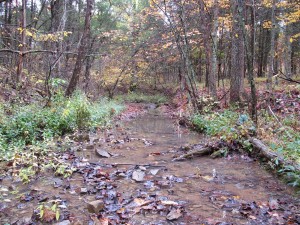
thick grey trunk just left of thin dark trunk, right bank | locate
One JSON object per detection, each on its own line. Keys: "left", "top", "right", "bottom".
{"left": 230, "top": 0, "right": 245, "bottom": 104}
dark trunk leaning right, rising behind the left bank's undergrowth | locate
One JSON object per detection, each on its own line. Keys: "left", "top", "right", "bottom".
{"left": 65, "top": 0, "right": 93, "bottom": 96}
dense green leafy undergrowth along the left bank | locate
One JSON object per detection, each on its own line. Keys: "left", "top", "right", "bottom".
{"left": 0, "top": 93, "right": 123, "bottom": 159}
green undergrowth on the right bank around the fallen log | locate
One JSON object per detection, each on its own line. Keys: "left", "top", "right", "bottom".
{"left": 191, "top": 110, "right": 300, "bottom": 187}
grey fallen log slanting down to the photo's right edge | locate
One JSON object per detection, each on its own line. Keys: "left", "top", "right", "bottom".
{"left": 249, "top": 138, "right": 300, "bottom": 171}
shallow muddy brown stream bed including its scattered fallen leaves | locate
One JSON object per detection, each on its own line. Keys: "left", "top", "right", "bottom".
{"left": 0, "top": 110, "right": 300, "bottom": 224}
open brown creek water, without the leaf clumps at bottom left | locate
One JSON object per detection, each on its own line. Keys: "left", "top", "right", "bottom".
{"left": 0, "top": 111, "right": 299, "bottom": 224}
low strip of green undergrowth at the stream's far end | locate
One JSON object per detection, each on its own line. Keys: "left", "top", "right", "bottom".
{"left": 116, "top": 92, "right": 168, "bottom": 104}
